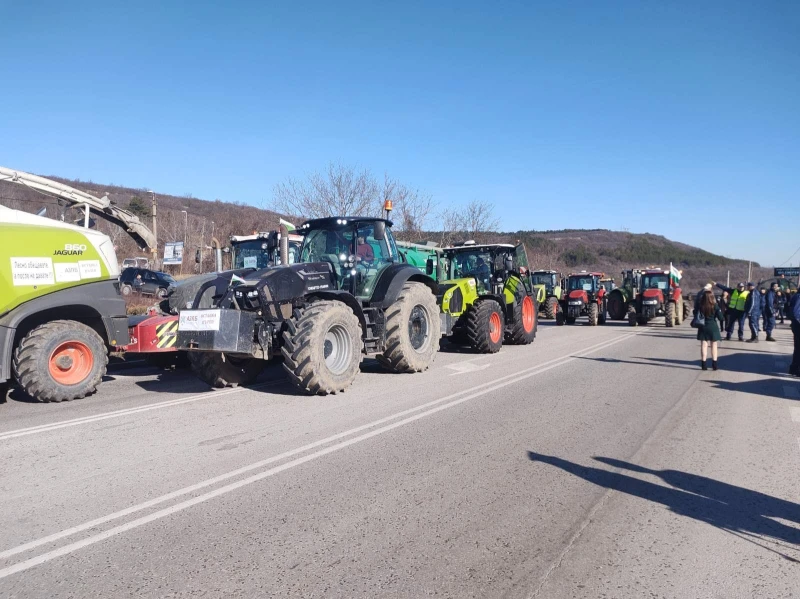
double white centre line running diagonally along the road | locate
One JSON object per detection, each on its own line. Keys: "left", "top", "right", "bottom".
{"left": 0, "top": 333, "right": 638, "bottom": 578}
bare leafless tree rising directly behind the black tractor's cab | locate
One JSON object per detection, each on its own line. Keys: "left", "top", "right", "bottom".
{"left": 273, "top": 162, "right": 381, "bottom": 218}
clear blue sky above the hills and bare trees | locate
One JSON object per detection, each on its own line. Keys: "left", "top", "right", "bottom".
{"left": 0, "top": 0, "right": 800, "bottom": 264}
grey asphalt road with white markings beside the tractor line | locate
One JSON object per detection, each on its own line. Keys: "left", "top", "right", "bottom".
{"left": 0, "top": 322, "right": 800, "bottom": 599}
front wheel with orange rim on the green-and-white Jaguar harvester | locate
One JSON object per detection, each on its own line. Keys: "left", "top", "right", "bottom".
{"left": 13, "top": 320, "right": 108, "bottom": 401}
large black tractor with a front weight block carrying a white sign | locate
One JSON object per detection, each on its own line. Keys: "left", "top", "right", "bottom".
{"left": 177, "top": 217, "right": 441, "bottom": 395}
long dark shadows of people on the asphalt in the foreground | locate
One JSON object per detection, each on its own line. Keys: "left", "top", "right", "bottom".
{"left": 528, "top": 451, "right": 800, "bottom": 563}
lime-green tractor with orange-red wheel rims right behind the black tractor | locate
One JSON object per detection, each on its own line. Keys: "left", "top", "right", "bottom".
{"left": 439, "top": 242, "right": 538, "bottom": 353}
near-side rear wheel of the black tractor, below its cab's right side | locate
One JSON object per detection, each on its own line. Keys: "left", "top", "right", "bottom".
{"left": 377, "top": 281, "right": 442, "bottom": 372}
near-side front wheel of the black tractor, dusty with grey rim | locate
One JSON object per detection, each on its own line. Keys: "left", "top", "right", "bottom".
{"left": 281, "top": 300, "right": 363, "bottom": 395}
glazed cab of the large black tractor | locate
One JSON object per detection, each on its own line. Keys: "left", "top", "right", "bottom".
{"left": 299, "top": 217, "right": 401, "bottom": 301}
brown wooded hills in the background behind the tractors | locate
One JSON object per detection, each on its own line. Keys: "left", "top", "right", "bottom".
{"left": 0, "top": 176, "right": 772, "bottom": 291}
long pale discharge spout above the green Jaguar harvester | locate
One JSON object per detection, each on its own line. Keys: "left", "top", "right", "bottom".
{"left": 0, "top": 166, "right": 156, "bottom": 251}
